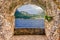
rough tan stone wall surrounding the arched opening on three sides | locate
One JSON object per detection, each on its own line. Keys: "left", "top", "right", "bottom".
{"left": 0, "top": 0, "right": 60, "bottom": 40}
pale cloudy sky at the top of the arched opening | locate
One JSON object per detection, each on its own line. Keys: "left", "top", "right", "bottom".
{"left": 17, "top": 4, "right": 43, "bottom": 14}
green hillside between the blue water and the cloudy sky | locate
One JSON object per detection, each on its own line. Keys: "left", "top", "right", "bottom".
{"left": 14, "top": 10, "right": 45, "bottom": 19}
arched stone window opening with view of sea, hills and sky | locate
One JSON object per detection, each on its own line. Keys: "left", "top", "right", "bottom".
{"left": 14, "top": 4, "right": 45, "bottom": 35}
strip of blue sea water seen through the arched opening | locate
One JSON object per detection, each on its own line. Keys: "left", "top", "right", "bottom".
{"left": 15, "top": 19, "right": 44, "bottom": 28}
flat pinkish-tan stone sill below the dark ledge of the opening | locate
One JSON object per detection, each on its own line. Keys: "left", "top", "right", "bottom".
{"left": 12, "top": 35, "right": 48, "bottom": 40}
